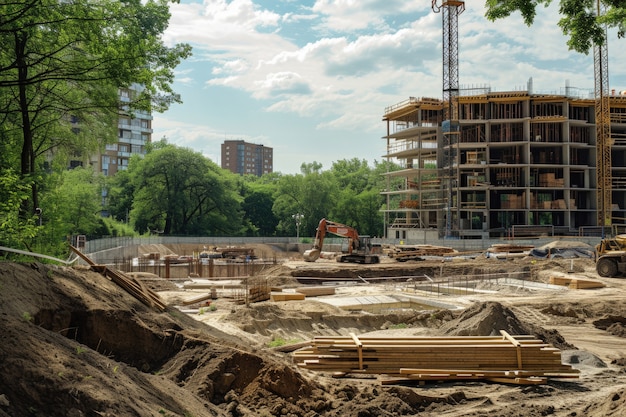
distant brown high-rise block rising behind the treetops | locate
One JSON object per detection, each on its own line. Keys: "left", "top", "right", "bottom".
{"left": 222, "top": 140, "right": 274, "bottom": 177}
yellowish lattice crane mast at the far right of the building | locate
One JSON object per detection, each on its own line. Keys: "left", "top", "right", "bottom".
{"left": 593, "top": 0, "right": 612, "bottom": 231}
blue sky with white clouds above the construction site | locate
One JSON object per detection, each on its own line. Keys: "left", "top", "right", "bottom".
{"left": 152, "top": 0, "right": 626, "bottom": 174}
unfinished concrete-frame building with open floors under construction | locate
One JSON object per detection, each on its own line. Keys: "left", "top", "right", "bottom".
{"left": 383, "top": 91, "right": 626, "bottom": 240}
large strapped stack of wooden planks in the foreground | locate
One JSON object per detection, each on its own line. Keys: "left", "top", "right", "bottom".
{"left": 294, "top": 331, "right": 578, "bottom": 384}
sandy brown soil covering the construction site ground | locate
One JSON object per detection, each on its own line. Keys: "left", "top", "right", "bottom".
{"left": 0, "top": 242, "right": 626, "bottom": 417}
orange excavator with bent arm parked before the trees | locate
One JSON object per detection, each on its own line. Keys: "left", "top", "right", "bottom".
{"left": 303, "top": 219, "right": 380, "bottom": 264}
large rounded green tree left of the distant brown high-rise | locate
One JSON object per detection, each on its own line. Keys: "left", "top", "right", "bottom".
{"left": 128, "top": 142, "right": 242, "bottom": 236}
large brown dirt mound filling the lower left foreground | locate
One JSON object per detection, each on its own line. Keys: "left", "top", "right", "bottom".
{"left": 0, "top": 263, "right": 332, "bottom": 416}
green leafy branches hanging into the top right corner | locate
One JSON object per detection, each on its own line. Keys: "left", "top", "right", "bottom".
{"left": 486, "top": 0, "right": 626, "bottom": 54}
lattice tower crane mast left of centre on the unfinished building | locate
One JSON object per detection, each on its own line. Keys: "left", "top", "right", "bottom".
{"left": 432, "top": 0, "right": 465, "bottom": 237}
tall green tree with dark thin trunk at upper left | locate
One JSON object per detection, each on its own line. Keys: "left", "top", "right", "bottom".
{"left": 0, "top": 0, "right": 190, "bottom": 216}
